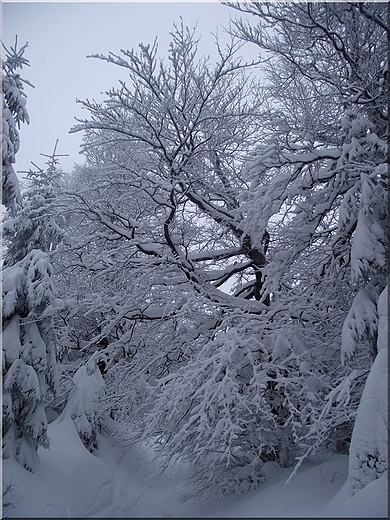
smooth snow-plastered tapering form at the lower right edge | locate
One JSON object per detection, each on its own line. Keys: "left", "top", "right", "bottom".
{"left": 349, "top": 286, "right": 389, "bottom": 494}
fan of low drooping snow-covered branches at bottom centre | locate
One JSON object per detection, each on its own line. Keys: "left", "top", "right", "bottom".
{"left": 134, "top": 315, "right": 320, "bottom": 494}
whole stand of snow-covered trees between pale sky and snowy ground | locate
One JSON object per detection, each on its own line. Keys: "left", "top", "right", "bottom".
{"left": 2, "top": 2, "right": 389, "bottom": 516}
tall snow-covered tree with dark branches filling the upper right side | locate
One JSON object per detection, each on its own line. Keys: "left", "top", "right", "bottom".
{"left": 228, "top": 2, "right": 389, "bottom": 492}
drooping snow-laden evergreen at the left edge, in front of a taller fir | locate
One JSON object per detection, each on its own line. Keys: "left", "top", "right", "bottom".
{"left": 2, "top": 249, "right": 58, "bottom": 471}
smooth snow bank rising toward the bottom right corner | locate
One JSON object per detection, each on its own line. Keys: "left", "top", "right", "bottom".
{"left": 213, "top": 456, "right": 388, "bottom": 518}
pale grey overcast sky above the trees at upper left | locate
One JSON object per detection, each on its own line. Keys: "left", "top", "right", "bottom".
{"left": 2, "top": 0, "right": 256, "bottom": 176}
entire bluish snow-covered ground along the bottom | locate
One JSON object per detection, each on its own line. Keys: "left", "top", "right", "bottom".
{"left": 3, "top": 417, "right": 388, "bottom": 518}
